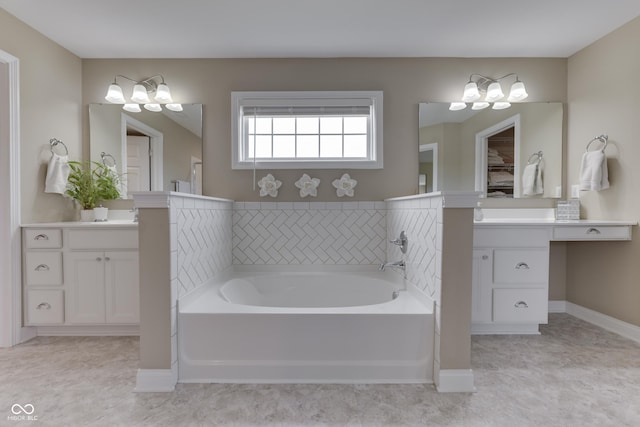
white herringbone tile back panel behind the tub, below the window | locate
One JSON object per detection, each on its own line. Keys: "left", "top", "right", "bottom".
{"left": 233, "top": 202, "right": 386, "bottom": 265}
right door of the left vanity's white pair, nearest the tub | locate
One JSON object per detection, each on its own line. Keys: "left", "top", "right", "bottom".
{"left": 104, "top": 251, "right": 140, "bottom": 323}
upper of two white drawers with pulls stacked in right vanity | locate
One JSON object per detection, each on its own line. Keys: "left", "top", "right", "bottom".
{"left": 493, "top": 249, "right": 549, "bottom": 284}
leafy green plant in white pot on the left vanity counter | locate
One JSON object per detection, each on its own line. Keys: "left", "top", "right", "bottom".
{"left": 65, "top": 161, "right": 120, "bottom": 221}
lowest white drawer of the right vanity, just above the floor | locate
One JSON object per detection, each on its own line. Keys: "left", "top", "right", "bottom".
{"left": 493, "top": 289, "right": 549, "bottom": 323}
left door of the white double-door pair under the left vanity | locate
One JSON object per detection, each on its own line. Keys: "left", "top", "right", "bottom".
{"left": 64, "top": 252, "right": 105, "bottom": 324}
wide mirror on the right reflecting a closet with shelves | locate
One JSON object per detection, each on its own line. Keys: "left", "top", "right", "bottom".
{"left": 418, "top": 102, "right": 564, "bottom": 198}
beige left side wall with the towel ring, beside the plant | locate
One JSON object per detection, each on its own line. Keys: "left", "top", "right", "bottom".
{"left": 0, "top": 9, "right": 84, "bottom": 223}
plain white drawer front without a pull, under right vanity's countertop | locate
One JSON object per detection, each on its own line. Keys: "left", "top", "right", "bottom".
{"left": 473, "top": 225, "right": 551, "bottom": 248}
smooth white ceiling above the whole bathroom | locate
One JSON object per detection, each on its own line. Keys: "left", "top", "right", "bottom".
{"left": 0, "top": 0, "right": 640, "bottom": 58}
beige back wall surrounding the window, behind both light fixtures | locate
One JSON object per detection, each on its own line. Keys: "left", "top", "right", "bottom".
{"left": 82, "top": 58, "right": 566, "bottom": 201}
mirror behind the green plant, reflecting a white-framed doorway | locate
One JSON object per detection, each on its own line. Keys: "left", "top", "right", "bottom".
{"left": 89, "top": 104, "right": 202, "bottom": 198}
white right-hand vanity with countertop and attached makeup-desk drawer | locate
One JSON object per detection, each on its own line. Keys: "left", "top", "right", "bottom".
{"left": 471, "top": 217, "right": 634, "bottom": 334}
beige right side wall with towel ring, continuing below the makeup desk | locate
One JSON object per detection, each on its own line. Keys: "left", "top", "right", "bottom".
{"left": 566, "top": 18, "right": 640, "bottom": 326}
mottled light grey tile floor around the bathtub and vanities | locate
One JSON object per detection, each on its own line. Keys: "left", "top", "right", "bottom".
{"left": 0, "top": 314, "right": 640, "bottom": 427}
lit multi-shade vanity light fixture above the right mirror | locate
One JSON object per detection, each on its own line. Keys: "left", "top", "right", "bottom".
{"left": 449, "top": 73, "right": 529, "bottom": 111}
